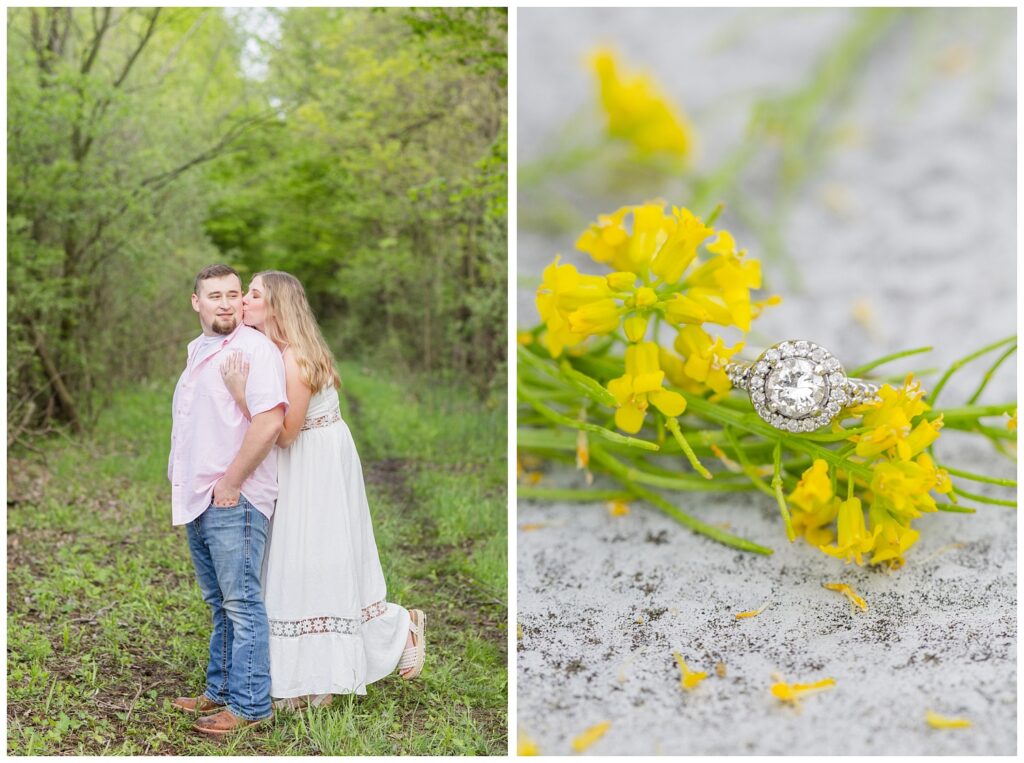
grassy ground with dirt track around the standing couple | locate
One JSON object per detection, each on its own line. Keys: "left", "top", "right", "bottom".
{"left": 7, "top": 365, "right": 508, "bottom": 755}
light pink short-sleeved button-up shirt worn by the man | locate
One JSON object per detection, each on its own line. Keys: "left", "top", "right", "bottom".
{"left": 167, "top": 325, "right": 288, "bottom": 524}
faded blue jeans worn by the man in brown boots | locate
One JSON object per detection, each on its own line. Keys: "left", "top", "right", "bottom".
{"left": 187, "top": 496, "right": 271, "bottom": 721}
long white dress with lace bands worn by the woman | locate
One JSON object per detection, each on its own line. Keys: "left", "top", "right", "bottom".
{"left": 263, "top": 386, "right": 410, "bottom": 698}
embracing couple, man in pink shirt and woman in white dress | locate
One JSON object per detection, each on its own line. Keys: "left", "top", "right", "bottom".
{"left": 168, "top": 265, "right": 425, "bottom": 734}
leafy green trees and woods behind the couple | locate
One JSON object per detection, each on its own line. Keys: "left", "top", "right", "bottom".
{"left": 7, "top": 8, "right": 508, "bottom": 444}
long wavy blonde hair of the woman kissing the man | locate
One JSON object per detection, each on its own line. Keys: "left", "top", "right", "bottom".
{"left": 253, "top": 270, "right": 341, "bottom": 392}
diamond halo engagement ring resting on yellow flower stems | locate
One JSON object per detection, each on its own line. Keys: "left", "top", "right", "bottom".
{"left": 725, "top": 340, "right": 879, "bottom": 432}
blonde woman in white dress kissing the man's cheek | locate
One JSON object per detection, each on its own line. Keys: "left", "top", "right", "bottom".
{"left": 221, "top": 270, "right": 426, "bottom": 708}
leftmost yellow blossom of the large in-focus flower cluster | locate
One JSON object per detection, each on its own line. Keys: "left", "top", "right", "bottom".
{"left": 537, "top": 252, "right": 617, "bottom": 357}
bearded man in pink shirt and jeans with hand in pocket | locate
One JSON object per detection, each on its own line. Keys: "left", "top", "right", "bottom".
{"left": 167, "top": 265, "right": 288, "bottom": 735}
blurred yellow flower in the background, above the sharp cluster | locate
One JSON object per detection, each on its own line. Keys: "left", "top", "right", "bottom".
{"left": 592, "top": 50, "right": 693, "bottom": 157}
